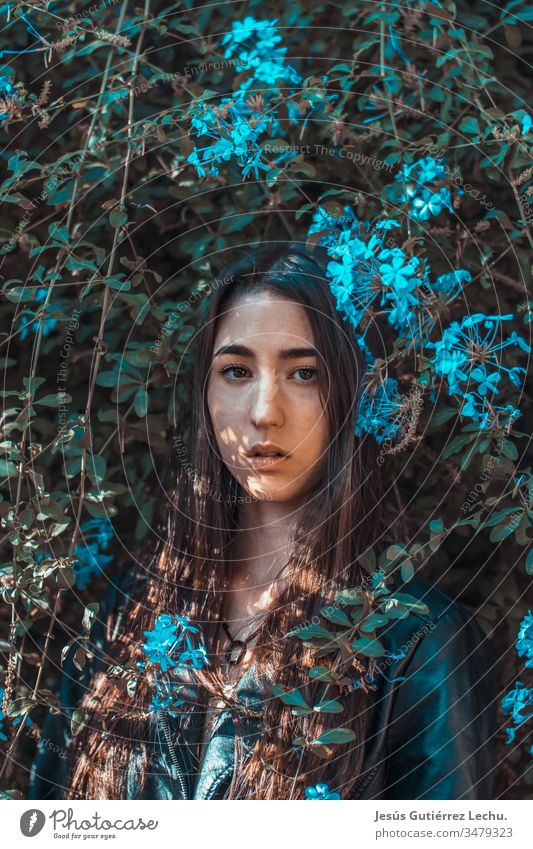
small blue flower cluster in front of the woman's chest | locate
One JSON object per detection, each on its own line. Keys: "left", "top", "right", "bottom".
{"left": 141, "top": 613, "right": 209, "bottom": 712}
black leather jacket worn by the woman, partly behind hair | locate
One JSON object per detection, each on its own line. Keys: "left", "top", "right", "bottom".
{"left": 29, "top": 575, "right": 498, "bottom": 800}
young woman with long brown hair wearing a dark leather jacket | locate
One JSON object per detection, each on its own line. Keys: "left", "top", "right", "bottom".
{"left": 30, "top": 244, "right": 496, "bottom": 799}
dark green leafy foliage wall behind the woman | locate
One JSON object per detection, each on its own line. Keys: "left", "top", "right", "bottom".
{"left": 0, "top": 0, "right": 533, "bottom": 799}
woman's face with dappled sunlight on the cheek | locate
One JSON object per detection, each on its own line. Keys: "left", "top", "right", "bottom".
{"left": 207, "top": 291, "right": 329, "bottom": 506}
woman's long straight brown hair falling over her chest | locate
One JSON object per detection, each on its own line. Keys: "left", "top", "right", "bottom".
{"left": 68, "top": 243, "right": 396, "bottom": 799}
